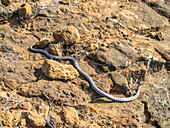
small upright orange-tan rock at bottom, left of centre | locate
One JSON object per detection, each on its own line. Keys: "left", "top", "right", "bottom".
{"left": 63, "top": 107, "right": 79, "bottom": 124}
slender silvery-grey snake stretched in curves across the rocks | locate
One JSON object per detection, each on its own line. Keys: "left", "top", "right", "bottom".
{"left": 30, "top": 44, "right": 143, "bottom": 102}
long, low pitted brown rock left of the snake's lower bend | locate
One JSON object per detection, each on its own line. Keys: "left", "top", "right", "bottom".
{"left": 18, "top": 80, "right": 91, "bottom": 106}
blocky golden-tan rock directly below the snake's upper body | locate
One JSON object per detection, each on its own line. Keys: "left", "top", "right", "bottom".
{"left": 41, "top": 60, "right": 79, "bottom": 80}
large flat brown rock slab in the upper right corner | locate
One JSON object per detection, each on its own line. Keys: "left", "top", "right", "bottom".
{"left": 119, "top": 0, "right": 170, "bottom": 31}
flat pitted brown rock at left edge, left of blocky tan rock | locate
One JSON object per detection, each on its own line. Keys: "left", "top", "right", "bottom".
{"left": 0, "top": 61, "right": 37, "bottom": 89}
